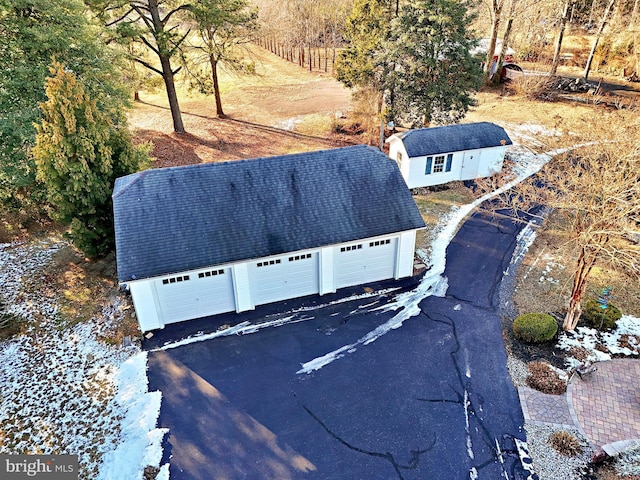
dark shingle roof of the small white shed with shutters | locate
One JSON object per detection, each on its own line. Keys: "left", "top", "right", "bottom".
{"left": 388, "top": 122, "right": 513, "bottom": 157}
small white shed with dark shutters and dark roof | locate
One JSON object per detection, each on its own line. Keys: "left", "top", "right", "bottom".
{"left": 387, "top": 122, "right": 513, "bottom": 188}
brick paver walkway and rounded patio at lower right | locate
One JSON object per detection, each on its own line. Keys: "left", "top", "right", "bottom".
{"left": 518, "top": 359, "right": 640, "bottom": 454}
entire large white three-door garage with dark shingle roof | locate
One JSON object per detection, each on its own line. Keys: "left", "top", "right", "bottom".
{"left": 113, "top": 145, "right": 424, "bottom": 331}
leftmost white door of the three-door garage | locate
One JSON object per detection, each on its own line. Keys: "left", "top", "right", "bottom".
{"left": 156, "top": 268, "right": 235, "bottom": 323}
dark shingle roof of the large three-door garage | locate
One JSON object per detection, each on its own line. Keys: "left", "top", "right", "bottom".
{"left": 113, "top": 145, "right": 424, "bottom": 282}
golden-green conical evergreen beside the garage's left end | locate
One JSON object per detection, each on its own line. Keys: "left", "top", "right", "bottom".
{"left": 32, "top": 63, "right": 148, "bottom": 257}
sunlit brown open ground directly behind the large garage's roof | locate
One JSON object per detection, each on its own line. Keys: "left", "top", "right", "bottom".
{"left": 129, "top": 48, "right": 352, "bottom": 167}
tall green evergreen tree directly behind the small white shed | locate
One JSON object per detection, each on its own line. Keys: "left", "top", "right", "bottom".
{"left": 381, "top": 0, "right": 482, "bottom": 125}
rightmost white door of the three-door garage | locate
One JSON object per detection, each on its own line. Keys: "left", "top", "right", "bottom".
{"left": 334, "top": 238, "right": 398, "bottom": 288}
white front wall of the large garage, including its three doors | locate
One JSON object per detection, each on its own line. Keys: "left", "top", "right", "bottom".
{"left": 129, "top": 230, "right": 416, "bottom": 332}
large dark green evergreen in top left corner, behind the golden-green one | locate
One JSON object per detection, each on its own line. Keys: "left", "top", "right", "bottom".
{"left": 0, "top": 0, "right": 125, "bottom": 209}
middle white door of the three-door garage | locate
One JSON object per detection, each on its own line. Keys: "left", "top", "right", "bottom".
{"left": 249, "top": 252, "right": 320, "bottom": 305}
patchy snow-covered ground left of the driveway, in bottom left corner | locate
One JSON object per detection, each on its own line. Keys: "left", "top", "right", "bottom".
{"left": 0, "top": 241, "right": 168, "bottom": 480}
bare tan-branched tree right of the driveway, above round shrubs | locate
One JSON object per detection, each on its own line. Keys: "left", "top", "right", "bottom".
{"left": 482, "top": 112, "right": 640, "bottom": 330}
